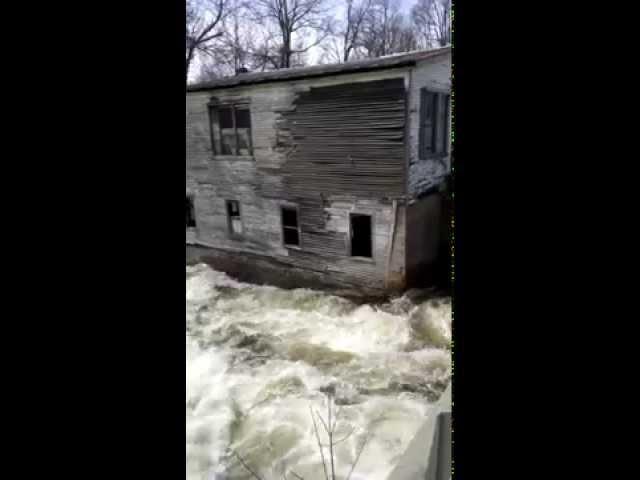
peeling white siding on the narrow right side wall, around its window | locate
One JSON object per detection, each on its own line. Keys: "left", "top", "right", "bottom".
{"left": 407, "top": 54, "right": 451, "bottom": 197}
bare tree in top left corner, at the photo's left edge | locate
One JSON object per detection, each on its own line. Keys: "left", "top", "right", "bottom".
{"left": 184, "top": 0, "right": 228, "bottom": 80}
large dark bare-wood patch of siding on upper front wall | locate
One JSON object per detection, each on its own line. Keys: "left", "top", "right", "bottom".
{"left": 284, "top": 78, "right": 405, "bottom": 199}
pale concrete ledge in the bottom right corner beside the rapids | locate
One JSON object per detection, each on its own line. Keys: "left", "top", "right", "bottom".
{"left": 387, "top": 383, "right": 451, "bottom": 480}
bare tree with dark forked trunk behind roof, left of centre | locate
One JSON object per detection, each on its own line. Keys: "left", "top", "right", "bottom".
{"left": 250, "top": 0, "right": 331, "bottom": 68}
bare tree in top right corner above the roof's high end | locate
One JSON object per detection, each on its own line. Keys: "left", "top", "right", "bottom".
{"left": 411, "top": 0, "right": 451, "bottom": 48}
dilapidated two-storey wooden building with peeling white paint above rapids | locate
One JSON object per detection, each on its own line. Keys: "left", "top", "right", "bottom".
{"left": 186, "top": 47, "right": 451, "bottom": 294}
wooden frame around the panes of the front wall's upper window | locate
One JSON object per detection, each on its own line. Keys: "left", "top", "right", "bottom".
{"left": 207, "top": 98, "right": 254, "bottom": 159}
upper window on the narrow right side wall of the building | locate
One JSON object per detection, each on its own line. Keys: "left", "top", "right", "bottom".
{"left": 418, "top": 88, "right": 450, "bottom": 160}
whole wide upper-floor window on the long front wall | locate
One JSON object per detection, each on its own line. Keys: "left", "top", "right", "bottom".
{"left": 209, "top": 101, "right": 253, "bottom": 155}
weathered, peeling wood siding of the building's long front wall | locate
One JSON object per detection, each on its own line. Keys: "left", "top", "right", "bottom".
{"left": 187, "top": 68, "right": 408, "bottom": 288}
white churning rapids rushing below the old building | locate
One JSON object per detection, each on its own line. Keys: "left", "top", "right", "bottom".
{"left": 186, "top": 264, "right": 451, "bottom": 480}
